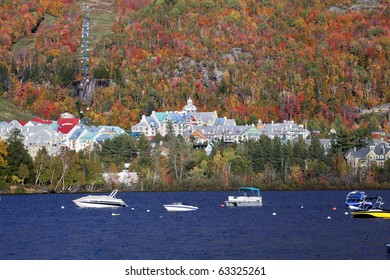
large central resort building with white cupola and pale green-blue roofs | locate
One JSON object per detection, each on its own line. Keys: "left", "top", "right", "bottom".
{"left": 131, "top": 98, "right": 310, "bottom": 146}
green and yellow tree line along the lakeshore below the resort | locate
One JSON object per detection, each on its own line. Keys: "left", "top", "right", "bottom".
{"left": 0, "top": 126, "right": 390, "bottom": 193}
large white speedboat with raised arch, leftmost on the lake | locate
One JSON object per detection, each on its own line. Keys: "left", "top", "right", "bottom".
{"left": 73, "top": 190, "right": 127, "bottom": 208}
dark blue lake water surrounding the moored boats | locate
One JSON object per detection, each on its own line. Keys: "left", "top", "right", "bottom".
{"left": 0, "top": 190, "right": 390, "bottom": 260}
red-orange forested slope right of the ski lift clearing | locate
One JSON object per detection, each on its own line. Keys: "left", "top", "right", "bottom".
{"left": 93, "top": 0, "right": 390, "bottom": 127}
